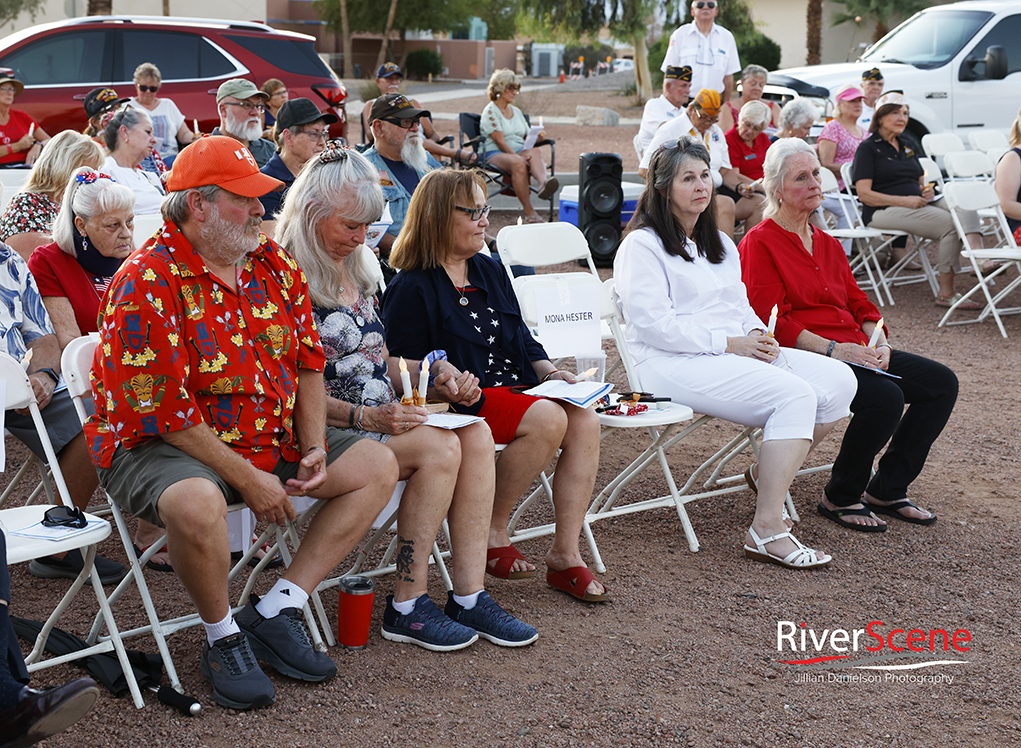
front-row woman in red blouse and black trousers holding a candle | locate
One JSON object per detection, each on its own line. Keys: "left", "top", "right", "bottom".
{"left": 740, "top": 138, "right": 958, "bottom": 533}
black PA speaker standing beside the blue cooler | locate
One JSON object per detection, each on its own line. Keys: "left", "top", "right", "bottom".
{"left": 578, "top": 153, "right": 624, "bottom": 267}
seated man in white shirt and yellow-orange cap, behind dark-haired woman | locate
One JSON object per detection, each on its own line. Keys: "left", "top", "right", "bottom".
{"left": 638, "top": 89, "right": 766, "bottom": 239}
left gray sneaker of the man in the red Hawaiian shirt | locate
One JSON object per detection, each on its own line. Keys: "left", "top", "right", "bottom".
{"left": 201, "top": 633, "right": 277, "bottom": 709}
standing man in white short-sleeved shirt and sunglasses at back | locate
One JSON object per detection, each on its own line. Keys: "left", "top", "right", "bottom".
{"left": 660, "top": 0, "right": 741, "bottom": 101}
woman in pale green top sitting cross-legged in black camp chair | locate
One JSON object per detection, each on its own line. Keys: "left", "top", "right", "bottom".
{"left": 479, "top": 69, "right": 561, "bottom": 223}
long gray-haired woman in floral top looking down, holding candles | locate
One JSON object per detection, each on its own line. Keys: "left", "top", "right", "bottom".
{"left": 278, "top": 144, "right": 538, "bottom": 651}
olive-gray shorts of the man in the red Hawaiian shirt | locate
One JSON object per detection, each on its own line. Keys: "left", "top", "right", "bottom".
{"left": 97, "top": 426, "right": 362, "bottom": 527}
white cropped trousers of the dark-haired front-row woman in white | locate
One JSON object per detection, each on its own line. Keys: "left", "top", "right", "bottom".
{"left": 638, "top": 348, "right": 858, "bottom": 441}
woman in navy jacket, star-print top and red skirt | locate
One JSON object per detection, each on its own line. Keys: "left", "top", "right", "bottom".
{"left": 383, "top": 170, "right": 609, "bottom": 602}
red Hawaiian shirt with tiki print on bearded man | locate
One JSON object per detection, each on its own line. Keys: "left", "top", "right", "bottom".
{"left": 85, "top": 222, "right": 325, "bottom": 470}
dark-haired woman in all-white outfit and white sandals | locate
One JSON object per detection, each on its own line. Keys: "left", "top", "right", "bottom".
{"left": 614, "top": 139, "right": 857, "bottom": 568}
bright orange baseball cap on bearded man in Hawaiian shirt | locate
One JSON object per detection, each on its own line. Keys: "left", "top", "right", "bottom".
{"left": 166, "top": 135, "right": 284, "bottom": 197}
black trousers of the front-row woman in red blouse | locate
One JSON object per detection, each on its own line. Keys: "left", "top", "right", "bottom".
{"left": 826, "top": 351, "right": 958, "bottom": 506}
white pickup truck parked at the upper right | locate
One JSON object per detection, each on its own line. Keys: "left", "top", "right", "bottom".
{"left": 764, "top": 0, "right": 1021, "bottom": 143}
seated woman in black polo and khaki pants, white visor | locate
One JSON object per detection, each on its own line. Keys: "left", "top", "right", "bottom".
{"left": 850, "top": 93, "right": 982, "bottom": 309}
